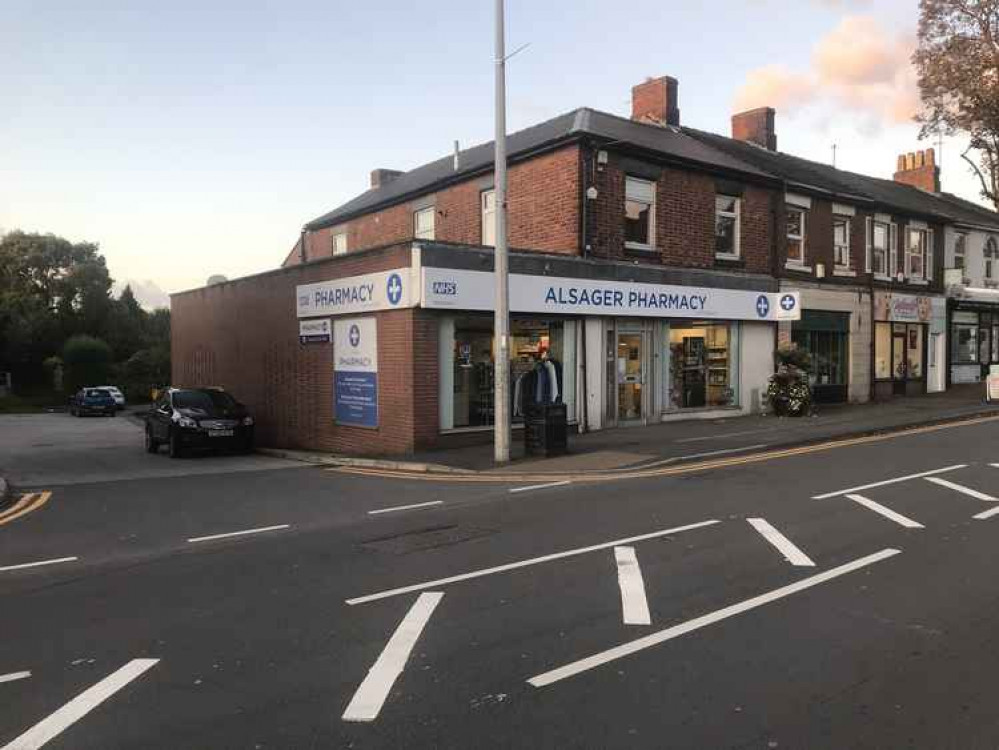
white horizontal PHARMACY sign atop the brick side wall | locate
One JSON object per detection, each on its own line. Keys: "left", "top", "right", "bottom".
{"left": 295, "top": 268, "right": 415, "bottom": 318}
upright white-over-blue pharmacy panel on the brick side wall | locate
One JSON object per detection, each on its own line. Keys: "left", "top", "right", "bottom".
{"left": 333, "top": 318, "right": 378, "bottom": 427}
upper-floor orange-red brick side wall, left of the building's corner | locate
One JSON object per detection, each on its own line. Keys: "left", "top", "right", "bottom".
{"left": 285, "top": 145, "right": 579, "bottom": 265}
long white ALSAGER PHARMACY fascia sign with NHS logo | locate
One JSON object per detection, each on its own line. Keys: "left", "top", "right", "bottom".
{"left": 422, "top": 268, "right": 801, "bottom": 320}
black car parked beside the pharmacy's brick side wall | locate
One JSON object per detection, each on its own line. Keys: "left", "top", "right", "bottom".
{"left": 146, "top": 388, "right": 253, "bottom": 458}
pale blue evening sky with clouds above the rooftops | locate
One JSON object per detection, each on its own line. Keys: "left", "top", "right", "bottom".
{"left": 0, "top": 0, "right": 979, "bottom": 307}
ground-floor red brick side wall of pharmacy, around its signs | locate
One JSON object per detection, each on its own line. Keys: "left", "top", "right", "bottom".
{"left": 171, "top": 246, "right": 438, "bottom": 455}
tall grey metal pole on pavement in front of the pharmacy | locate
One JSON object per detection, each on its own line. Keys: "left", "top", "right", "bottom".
{"left": 493, "top": 0, "right": 510, "bottom": 463}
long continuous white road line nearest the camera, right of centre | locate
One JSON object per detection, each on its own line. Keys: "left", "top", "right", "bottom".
{"left": 528, "top": 549, "right": 902, "bottom": 687}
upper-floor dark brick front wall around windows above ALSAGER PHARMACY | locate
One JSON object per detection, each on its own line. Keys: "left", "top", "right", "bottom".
{"left": 588, "top": 154, "right": 775, "bottom": 273}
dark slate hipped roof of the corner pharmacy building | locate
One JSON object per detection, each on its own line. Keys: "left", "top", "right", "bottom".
{"left": 305, "top": 107, "right": 775, "bottom": 229}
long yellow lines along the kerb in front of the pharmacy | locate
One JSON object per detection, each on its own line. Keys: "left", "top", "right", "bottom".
{"left": 329, "top": 416, "right": 999, "bottom": 484}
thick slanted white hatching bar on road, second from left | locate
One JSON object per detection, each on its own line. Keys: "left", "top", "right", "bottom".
{"left": 342, "top": 591, "right": 444, "bottom": 721}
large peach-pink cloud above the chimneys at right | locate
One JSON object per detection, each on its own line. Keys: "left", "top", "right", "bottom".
{"left": 735, "top": 15, "right": 919, "bottom": 125}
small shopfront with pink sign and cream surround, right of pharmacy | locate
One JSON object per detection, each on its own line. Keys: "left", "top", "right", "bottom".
{"left": 873, "top": 292, "right": 945, "bottom": 400}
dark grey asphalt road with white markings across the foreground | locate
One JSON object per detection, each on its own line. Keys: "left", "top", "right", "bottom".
{"left": 0, "top": 418, "right": 999, "bottom": 750}
